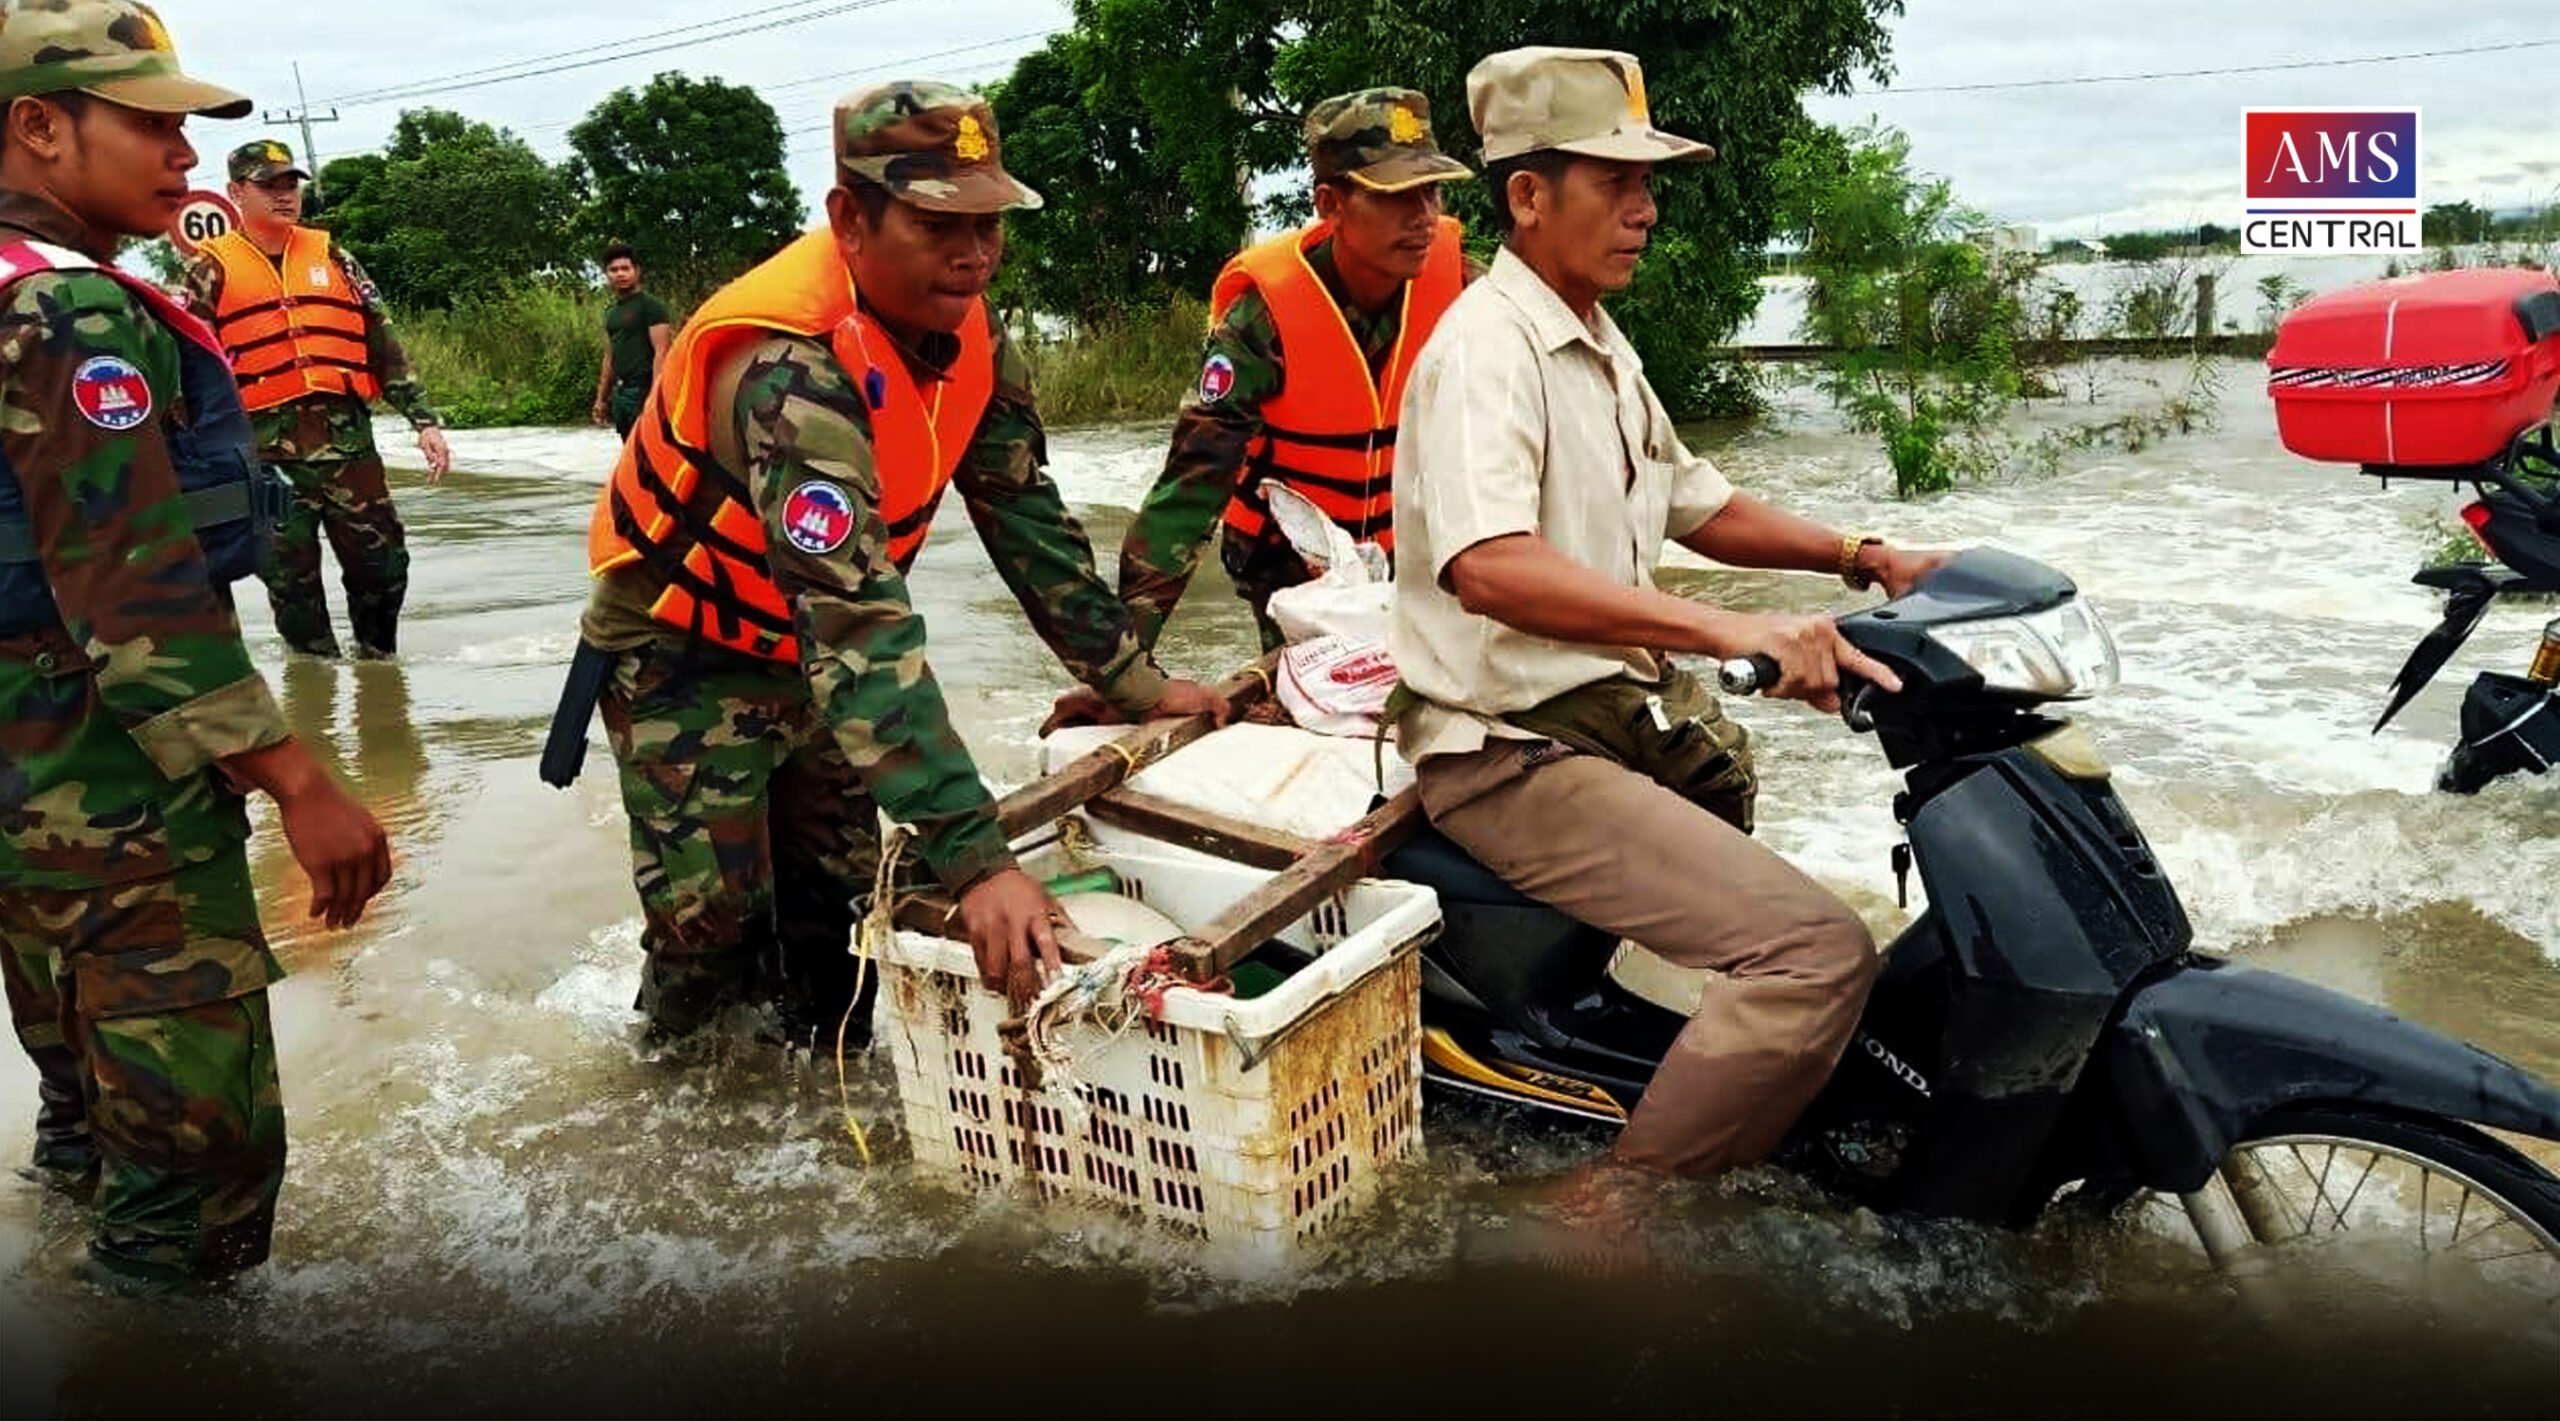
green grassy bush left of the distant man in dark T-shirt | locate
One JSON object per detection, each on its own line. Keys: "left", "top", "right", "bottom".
{"left": 392, "top": 284, "right": 607, "bottom": 428}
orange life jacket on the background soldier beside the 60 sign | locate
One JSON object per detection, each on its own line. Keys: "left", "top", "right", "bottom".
{"left": 205, "top": 228, "right": 381, "bottom": 410}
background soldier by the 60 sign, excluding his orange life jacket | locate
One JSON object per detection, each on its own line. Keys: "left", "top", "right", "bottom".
{"left": 187, "top": 138, "right": 453, "bottom": 658}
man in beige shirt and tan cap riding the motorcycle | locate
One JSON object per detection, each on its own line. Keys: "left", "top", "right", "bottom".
{"left": 1390, "top": 46, "right": 1943, "bottom": 1188}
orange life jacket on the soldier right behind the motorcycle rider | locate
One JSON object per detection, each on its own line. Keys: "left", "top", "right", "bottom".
{"left": 1208, "top": 218, "right": 1467, "bottom": 550}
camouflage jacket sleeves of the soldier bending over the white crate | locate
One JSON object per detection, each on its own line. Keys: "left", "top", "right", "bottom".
{"left": 584, "top": 307, "right": 1165, "bottom": 891}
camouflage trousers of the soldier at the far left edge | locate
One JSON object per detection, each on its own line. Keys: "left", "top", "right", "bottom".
{"left": 0, "top": 847, "right": 284, "bottom": 1280}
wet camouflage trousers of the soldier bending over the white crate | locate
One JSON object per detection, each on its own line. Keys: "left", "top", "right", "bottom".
{"left": 602, "top": 640, "right": 881, "bottom": 1045}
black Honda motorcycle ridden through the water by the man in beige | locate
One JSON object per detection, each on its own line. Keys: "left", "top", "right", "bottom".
{"left": 1380, "top": 550, "right": 2560, "bottom": 1298}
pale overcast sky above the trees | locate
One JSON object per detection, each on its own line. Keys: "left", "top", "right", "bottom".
{"left": 161, "top": 0, "right": 2560, "bottom": 236}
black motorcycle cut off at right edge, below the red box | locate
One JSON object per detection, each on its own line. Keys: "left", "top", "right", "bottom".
{"left": 2365, "top": 420, "right": 2560, "bottom": 794}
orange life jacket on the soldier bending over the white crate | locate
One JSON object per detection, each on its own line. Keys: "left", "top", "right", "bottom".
{"left": 586, "top": 228, "right": 996, "bottom": 661}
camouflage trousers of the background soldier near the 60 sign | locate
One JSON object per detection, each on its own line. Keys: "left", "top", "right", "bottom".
{"left": 259, "top": 410, "right": 410, "bottom": 655}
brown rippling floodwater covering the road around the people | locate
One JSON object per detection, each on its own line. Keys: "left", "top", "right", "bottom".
{"left": 0, "top": 364, "right": 2560, "bottom": 1416}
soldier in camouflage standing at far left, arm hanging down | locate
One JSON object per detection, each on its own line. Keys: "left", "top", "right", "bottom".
{"left": 0, "top": 0, "right": 389, "bottom": 1290}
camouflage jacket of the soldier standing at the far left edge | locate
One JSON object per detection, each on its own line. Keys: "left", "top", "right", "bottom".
{"left": 0, "top": 192, "right": 287, "bottom": 888}
